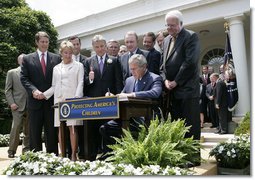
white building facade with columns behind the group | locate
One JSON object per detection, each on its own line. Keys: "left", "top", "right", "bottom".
{"left": 56, "top": 0, "right": 251, "bottom": 116}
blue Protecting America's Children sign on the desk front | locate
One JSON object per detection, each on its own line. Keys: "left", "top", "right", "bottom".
{"left": 58, "top": 96, "right": 119, "bottom": 121}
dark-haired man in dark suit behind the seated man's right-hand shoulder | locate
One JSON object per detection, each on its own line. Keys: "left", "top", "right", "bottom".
{"left": 143, "top": 32, "right": 161, "bottom": 74}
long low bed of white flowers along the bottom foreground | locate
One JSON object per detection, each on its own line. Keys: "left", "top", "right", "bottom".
{"left": 3, "top": 152, "right": 194, "bottom": 176}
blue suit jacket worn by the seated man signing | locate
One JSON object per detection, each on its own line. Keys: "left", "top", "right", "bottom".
{"left": 122, "top": 71, "right": 162, "bottom": 99}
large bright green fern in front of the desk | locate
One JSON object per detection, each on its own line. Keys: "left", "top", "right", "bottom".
{"left": 106, "top": 119, "right": 200, "bottom": 167}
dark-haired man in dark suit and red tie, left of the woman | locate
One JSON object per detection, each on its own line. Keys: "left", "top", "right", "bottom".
{"left": 20, "top": 32, "right": 61, "bottom": 155}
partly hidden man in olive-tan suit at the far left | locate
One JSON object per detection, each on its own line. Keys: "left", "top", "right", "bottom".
{"left": 5, "top": 54, "right": 29, "bottom": 158}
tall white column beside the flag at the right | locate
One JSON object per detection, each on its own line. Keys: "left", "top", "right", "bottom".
{"left": 225, "top": 14, "right": 251, "bottom": 116}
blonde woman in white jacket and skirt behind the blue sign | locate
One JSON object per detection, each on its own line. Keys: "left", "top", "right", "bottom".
{"left": 43, "top": 41, "right": 84, "bottom": 161}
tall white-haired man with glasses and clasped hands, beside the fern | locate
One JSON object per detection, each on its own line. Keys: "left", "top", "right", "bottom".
{"left": 160, "top": 10, "right": 201, "bottom": 140}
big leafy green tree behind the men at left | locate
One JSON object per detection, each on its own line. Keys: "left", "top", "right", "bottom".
{"left": 0, "top": 0, "right": 58, "bottom": 125}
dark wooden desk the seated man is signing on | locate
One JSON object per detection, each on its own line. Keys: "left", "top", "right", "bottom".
{"left": 60, "top": 98, "right": 157, "bottom": 160}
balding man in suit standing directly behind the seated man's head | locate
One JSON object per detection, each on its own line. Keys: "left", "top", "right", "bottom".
{"left": 119, "top": 31, "right": 149, "bottom": 84}
